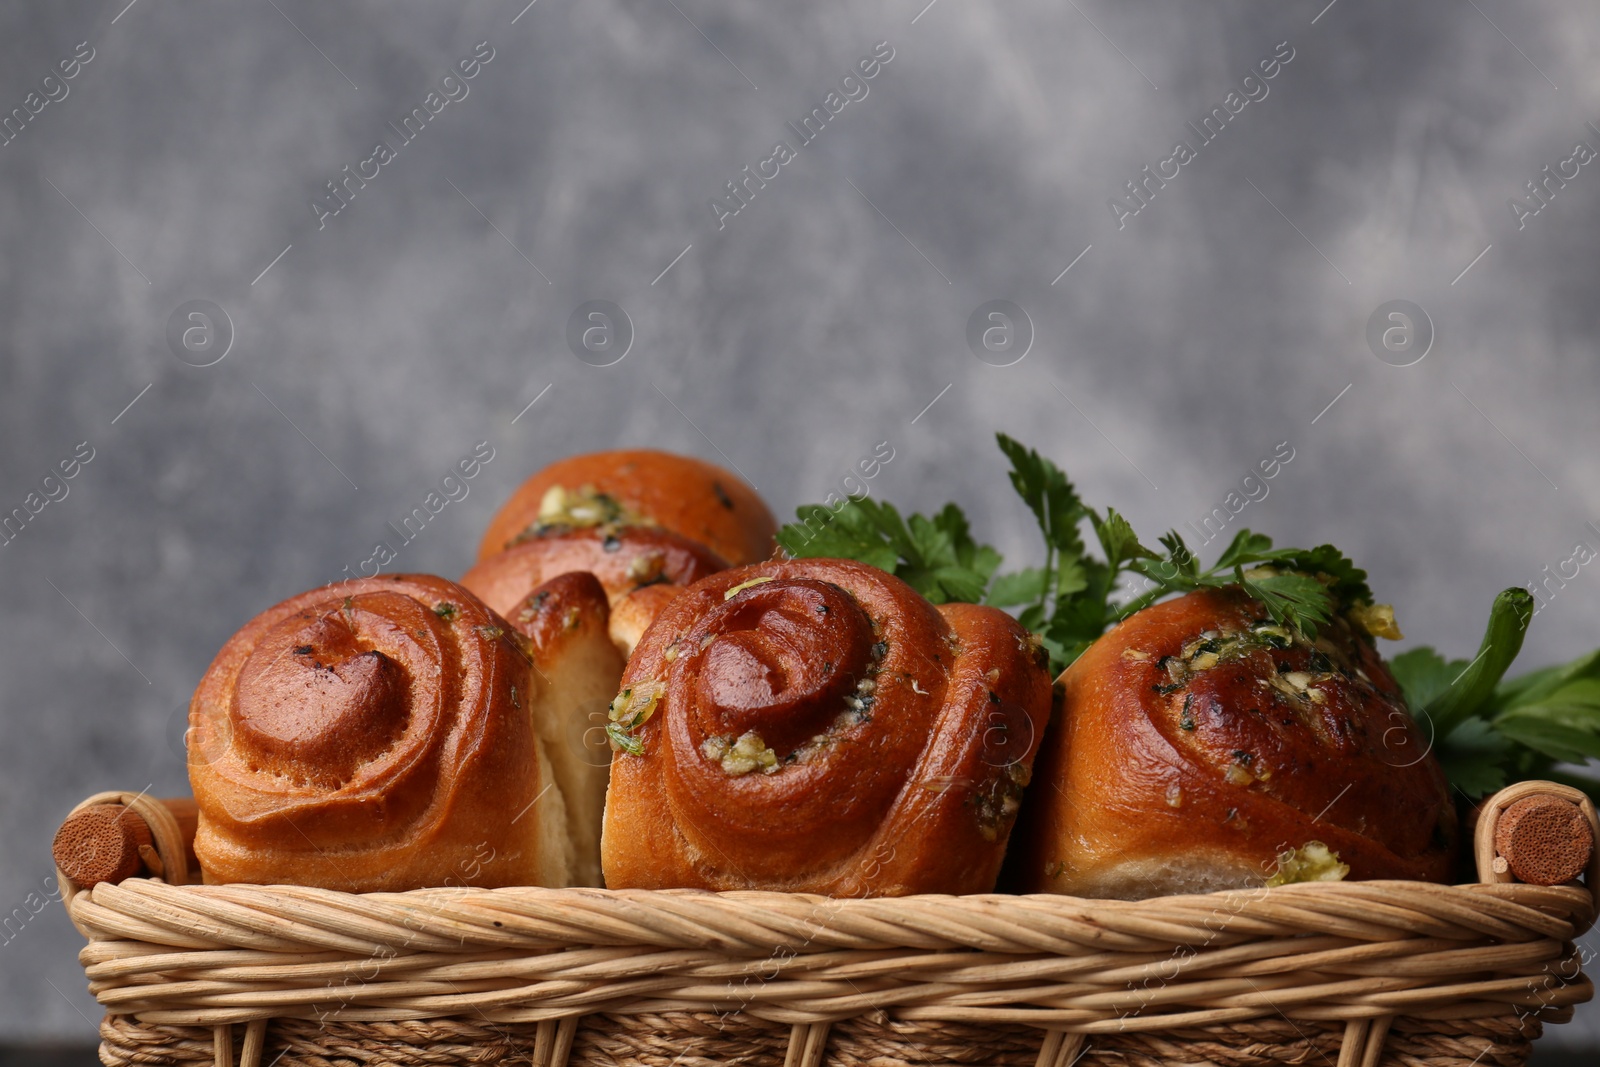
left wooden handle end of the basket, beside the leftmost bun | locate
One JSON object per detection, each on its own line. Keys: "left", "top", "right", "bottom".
{"left": 50, "top": 792, "right": 200, "bottom": 896}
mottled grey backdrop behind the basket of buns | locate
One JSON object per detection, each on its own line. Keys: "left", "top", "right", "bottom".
{"left": 0, "top": 0, "right": 1600, "bottom": 1045}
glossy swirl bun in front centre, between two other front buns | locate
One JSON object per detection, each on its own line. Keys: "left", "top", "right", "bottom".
{"left": 602, "top": 560, "right": 1051, "bottom": 896}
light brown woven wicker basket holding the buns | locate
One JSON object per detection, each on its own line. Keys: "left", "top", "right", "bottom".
{"left": 62, "top": 782, "right": 1600, "bottom": 1067}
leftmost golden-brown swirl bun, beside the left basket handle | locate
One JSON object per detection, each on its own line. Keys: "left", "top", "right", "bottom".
{"left": 189, "top": 574, "right": 582, "bottom": 893}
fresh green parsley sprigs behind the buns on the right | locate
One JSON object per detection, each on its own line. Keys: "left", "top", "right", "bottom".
{"left": 778, "top": 434, "right": 1600, "bottom": 801}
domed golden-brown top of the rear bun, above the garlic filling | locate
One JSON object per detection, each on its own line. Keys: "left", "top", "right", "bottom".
{"left": 478, "top": 450, "right": 778, "bottom": 566}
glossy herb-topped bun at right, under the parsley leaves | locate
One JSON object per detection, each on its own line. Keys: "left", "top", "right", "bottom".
{"left": 1018, "top": 587, "right": 1456, "bottom": 899}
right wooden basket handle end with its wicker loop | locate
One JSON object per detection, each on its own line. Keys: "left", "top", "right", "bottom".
{"left": 1474, "top": 782, "right": 1600, "bottom": 907}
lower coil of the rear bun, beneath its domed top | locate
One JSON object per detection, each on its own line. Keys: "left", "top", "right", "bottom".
{"left": 461, "top": 526, "right": 728, "bottom": 657}
